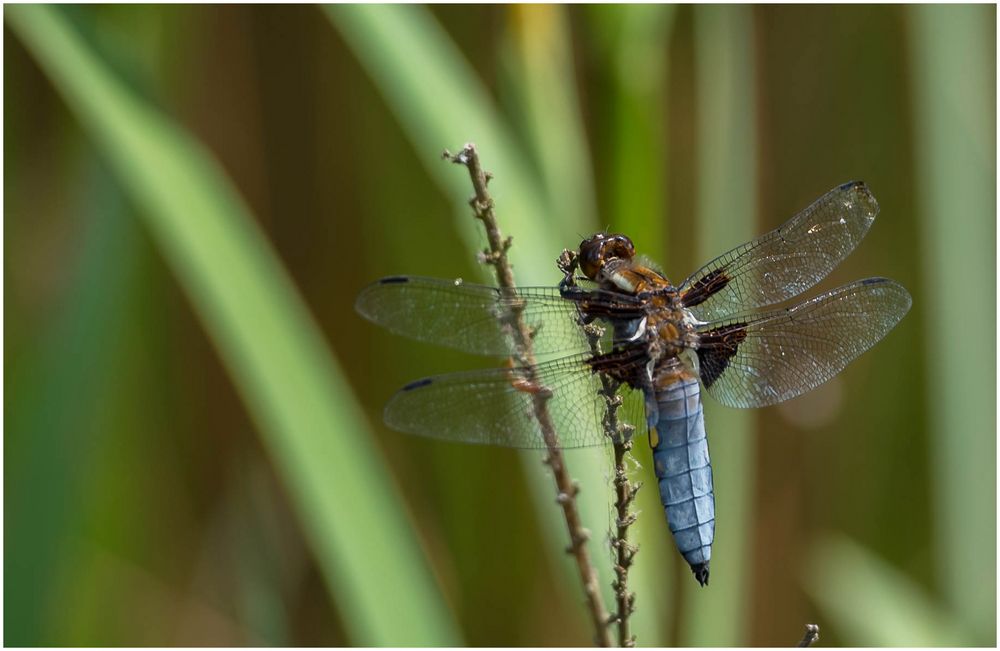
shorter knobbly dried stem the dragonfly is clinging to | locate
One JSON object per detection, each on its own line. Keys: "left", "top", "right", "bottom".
{"left": 557, "top": 250, "right": 642, "bottom": 647}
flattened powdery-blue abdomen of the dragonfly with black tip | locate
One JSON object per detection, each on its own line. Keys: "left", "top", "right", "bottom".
{"left": 651, "top": 378, "right": 715, "bottom": 585}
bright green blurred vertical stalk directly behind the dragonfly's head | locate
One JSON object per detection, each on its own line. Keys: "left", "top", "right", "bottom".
{"left": 586, "top": 5, "right": 677, "bottom": 646}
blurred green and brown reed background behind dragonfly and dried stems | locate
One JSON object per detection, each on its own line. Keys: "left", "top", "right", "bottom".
{"left": 4, "top": 5, "right": 996, "bottom": 646}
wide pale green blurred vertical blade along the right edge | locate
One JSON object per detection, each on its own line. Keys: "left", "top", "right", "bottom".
{"left": 910, "top": 5, "right": 997, "bottom": 645}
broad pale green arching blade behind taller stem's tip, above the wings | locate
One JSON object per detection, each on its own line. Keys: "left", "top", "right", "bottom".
{"left": 324, "top": 4, "right": 560, "bottom": 268}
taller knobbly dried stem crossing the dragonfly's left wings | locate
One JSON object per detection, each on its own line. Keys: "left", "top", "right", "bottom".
{"left": 444, "top": 143, "right": 612, "bottom": 646}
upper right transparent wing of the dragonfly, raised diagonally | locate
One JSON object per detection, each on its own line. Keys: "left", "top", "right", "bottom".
{"left": 680, "top": 181, "right": 878, "bottom": 321}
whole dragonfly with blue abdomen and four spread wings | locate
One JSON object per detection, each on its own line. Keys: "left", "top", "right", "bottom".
{"left": 356, "top": 181, "right": 911, "bottom": 586}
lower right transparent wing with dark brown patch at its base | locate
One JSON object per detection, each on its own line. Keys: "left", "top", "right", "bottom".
{"left": 697, "top": 278, "right": 911, "bottom": 407}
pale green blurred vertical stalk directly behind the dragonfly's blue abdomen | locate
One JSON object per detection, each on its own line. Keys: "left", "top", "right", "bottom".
{"left": 678, "top": 5, "right": 752, "bottom": 646}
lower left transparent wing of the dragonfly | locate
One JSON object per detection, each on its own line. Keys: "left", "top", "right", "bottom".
{"left": 385, "top": 355, "right": 645, "bottom": 448}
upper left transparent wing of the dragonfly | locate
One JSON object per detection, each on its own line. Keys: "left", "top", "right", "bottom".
{"left": 355, "top": 276, "right": 640, "bottom": 356}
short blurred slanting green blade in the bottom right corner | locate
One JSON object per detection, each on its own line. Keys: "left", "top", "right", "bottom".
{"left": 805, "top": 537, "right": 969, "bottom": 647}
